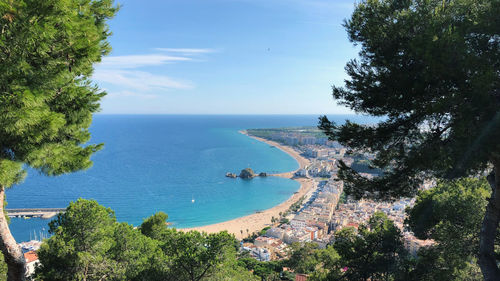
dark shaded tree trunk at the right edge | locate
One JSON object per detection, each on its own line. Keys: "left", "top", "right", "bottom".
{"left": 478, "top": 161, "right": 500, "bottom": 281}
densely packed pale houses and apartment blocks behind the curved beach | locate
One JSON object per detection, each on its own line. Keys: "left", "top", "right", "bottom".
{"left": 243, "top": 135, "right": 433, "bottom": 266}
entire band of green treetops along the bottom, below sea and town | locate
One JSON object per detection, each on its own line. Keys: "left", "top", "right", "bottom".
{"left": 31, "top": 178, "right": 492, "bottom": 281}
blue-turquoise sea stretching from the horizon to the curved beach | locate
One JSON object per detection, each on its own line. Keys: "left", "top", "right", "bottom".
{"left": 6, "top": 114, "right": 375, "bottom": 242}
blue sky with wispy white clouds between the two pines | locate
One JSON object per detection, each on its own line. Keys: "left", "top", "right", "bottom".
{"left": 92, "top": 0, "right": 358, "bottom": 114}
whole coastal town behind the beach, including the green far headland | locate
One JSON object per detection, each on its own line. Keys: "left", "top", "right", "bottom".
{"left": 241, "top": 128, "right": 433, "bottom": 261}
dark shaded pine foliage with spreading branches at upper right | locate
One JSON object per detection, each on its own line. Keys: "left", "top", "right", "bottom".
{"left": 320, "top": 0, "right": 500, "bottom": 198}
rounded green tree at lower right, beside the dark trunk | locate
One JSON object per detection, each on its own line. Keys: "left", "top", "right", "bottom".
{"left": 406, "top": 178, "right": 494, "bottom": 280}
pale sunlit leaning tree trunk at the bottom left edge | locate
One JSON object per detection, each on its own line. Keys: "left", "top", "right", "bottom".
{"left": 0, "top": 186, "right": 26, "bottom": 281}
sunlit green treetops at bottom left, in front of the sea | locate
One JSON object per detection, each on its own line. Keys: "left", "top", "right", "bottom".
{"left": 35, "top": 199, "right": 255, "bottom": 281}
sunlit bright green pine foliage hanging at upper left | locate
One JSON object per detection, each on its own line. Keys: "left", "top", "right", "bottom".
{"left": 0, "top": 0, "right": 117, "bottom": 187}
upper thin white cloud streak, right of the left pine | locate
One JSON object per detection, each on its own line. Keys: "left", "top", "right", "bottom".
{"left": 97, "top": 54, "right": 192, "bottom": 69}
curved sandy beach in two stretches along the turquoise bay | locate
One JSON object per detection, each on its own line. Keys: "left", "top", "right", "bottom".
{"left": 181, "top": 131, "right": 314, "bottom": 239}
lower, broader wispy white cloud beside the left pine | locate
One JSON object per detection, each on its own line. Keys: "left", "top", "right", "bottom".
{"left": 93, "top": 69, "right": 193, "bottom": 92}
